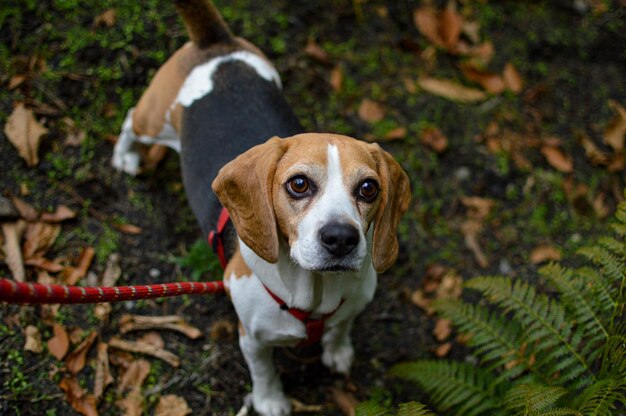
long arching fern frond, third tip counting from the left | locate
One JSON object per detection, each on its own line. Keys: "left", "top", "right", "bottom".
{"left": 465, "top": 276, "right": 595, "bottom": 384}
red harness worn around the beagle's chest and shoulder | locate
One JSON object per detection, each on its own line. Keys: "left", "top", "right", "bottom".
{"left": 209, "top": 208, "right": 344, "bottom": 347}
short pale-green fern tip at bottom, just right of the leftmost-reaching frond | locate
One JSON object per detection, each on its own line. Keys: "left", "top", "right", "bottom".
{"left": 502, "top": 384, "right": 567, "bottom": 415}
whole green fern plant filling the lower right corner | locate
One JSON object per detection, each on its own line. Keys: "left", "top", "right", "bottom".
{"left": 391, "top": 198, "right": 626, "bottom": 415}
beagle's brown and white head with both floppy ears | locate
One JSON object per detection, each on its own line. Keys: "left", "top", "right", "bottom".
{"left": 213, "top": 133, "right": 411, "bottom": 272}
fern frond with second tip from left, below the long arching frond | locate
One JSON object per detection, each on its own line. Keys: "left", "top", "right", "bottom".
{"left": 433, "top": 299, "right": 530, "bottom": 379}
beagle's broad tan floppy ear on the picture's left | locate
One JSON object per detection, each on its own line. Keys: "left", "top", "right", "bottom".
{"left": 212, "top": 137, "right": 285, "bottom": 263}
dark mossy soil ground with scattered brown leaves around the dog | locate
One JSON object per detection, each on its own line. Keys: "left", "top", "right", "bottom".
{"left": 0, "top": 0, "right": 626, "bottom": 415}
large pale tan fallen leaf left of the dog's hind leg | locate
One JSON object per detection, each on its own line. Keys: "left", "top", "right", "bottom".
{"left": 4, "top": 103, "right": 48, "bottom": 166}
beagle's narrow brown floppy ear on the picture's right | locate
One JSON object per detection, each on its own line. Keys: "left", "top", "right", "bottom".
{"left": 372, "top": 144, "right": 411, "bottom": 273}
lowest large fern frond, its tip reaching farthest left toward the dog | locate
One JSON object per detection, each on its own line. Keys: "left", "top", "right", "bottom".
{"left": 390, "top": 360, "right": 502, "bottom": 416}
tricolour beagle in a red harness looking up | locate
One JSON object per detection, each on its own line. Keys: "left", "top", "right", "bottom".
{"left": 112, "top": 0, "right": 411, "bottom": 416}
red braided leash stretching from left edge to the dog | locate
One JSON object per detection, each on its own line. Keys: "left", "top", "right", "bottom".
{"left": 0, "top": 279, "right": 224, "bottom": 304}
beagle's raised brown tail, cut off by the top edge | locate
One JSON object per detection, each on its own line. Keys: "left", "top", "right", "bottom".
{"left": 174, "top": 0, "right": 233, "bottom": 49}
